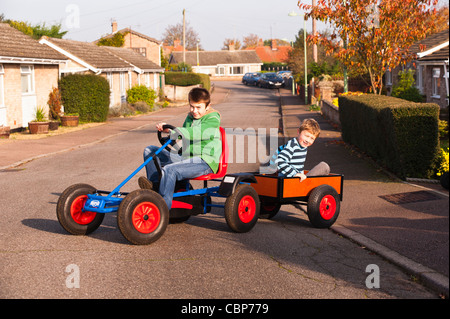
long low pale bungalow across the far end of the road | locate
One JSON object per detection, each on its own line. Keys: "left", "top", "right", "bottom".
{"left": 169, "top": 49, "right": 262, "bottom": 80}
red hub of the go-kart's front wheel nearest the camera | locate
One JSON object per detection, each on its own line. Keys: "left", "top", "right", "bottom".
{"left": 131, "top": 202, "right": 161, "bottom": 234}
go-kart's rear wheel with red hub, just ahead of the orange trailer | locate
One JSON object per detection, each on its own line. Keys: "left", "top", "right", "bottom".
{"left": 225, "top": 185, "right": 260, "bottom": 233}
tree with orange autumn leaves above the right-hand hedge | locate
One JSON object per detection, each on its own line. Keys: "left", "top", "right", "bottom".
{"left": 298, "top": 0, "right": 437, "bottom": 94}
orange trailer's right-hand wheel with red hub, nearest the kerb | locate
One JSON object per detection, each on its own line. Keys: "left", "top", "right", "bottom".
{"left": 307, "top": 185, "right": 341, "bottom": 228}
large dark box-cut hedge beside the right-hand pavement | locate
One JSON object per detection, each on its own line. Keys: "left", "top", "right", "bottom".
{"left": 339, "top": 94, "right": 439, "bottom": 178}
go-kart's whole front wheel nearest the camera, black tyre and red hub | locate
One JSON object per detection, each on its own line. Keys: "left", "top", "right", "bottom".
{"left": 117, "top": 189, "right": 169, "bottom": 245}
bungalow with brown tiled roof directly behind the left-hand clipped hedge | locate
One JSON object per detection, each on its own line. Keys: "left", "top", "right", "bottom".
{"left": 39, "top": 37, "right": 164, "bottom": 106}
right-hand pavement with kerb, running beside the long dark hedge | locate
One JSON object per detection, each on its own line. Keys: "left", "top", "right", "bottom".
{"left": 280, "top": 89, "right": 449, "bottom": 298}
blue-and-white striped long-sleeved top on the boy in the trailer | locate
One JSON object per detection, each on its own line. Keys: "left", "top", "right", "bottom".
{"left": 276, "top": 138, "right": 308, "bottom": 177}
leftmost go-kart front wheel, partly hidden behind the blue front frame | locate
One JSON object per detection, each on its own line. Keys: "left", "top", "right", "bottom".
{"left": 56, "top": 184, "right": 105, "bottom": 235}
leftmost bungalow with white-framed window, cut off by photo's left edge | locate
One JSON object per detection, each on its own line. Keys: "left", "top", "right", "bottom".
{"left": 0, "top": 23, "right": 67, "bottom": 130}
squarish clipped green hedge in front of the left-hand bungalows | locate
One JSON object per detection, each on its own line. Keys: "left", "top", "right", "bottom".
{"left": 59, "top": 74, "right": 110, "bottom": 122}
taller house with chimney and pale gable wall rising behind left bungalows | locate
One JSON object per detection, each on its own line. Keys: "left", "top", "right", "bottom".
{"left": 94, "top": 21, "right": 162, "bottom": 65}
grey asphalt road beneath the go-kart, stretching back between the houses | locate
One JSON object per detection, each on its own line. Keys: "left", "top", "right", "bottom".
{"left": 0, "top": 82, "right": 438, "bottom": 304}
